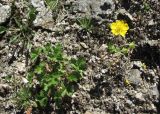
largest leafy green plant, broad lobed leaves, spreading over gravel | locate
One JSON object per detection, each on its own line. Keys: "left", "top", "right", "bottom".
{"left": 17, "top": 43, "right": 86, "bottom": 108}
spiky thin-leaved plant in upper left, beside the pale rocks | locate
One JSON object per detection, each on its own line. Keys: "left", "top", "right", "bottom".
{"left": 8, "top": 2, "right": 36, "bottom": 49}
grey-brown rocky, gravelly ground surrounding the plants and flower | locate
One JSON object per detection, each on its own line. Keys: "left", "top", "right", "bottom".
{"left": 0, "top": 0, "right": 160, "bottom": 114}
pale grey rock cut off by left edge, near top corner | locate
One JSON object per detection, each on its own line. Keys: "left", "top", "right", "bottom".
{"left": 0, "top": 4, "right": 11, "bottom": 24}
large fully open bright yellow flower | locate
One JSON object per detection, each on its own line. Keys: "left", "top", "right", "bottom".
{"left": 110, "top": 20, "right": 129, "bottom": 37}
